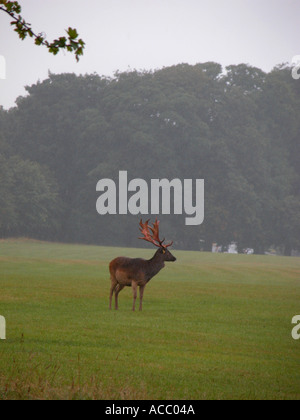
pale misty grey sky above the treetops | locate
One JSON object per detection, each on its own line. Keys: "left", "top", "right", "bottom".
{"left": 0, "top": 0, "right": 300, "bottom": 108}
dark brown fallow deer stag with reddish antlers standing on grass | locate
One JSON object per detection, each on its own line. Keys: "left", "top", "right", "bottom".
{"left": 109, "top": 219, "right": 176, "bottom": 311}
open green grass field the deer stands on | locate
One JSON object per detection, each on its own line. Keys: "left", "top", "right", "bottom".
{"left": 0, "top": 240, "right": 300, "bottom": 399}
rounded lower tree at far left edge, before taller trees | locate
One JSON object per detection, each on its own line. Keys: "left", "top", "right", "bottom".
{"left": 0, "top": 154, "right": 59, "bottom": 238}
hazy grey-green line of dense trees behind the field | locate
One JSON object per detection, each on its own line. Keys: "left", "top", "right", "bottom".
{"left": 0, "top": 62, "right": 300, "bottom": 255}
